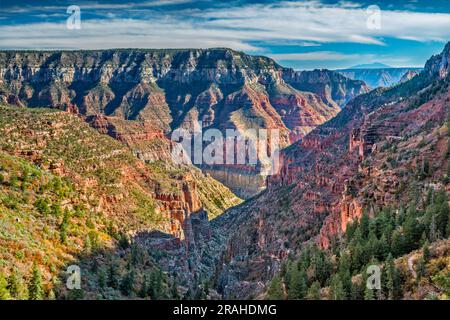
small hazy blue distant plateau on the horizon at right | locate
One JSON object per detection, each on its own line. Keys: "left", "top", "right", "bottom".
{"left": 337, "top": 67, "right": 422, "bottom": 89}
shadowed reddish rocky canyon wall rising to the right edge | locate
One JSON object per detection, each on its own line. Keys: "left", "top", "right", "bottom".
{"left": 196, "top": 42, "right": 450, "bottom": 297}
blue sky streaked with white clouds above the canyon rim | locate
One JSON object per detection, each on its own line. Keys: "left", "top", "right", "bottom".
{"left": 0, "top": 0, "right": 450, "bottom": 69}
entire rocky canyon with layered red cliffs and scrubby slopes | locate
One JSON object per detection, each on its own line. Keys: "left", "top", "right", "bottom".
{"left": 0, "top": 43, "right": 450, "bottom": 299}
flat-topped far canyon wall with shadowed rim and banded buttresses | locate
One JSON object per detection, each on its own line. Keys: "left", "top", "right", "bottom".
{"left": 0, "top": 49, "right": 367, "bottom": 197}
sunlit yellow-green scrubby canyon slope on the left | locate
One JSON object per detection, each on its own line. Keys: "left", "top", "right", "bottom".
{"left": 0, "top": 107, "right": 240, "bottom": 242}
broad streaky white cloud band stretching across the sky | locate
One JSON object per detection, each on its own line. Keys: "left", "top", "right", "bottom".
{"left": 0, "top": 0, "right": 450, "bottom": 50}
